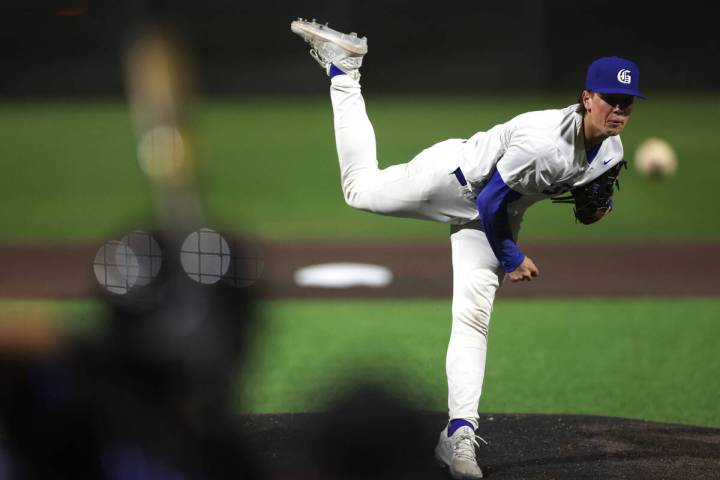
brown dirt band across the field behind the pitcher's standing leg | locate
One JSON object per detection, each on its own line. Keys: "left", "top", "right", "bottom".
{"left": 0, "top": 241, "right": 720, "bottom": 298}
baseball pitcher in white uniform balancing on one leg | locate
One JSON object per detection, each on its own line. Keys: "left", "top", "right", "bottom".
{"left": 290, "top": 19, "right": 644, "bottom": 479}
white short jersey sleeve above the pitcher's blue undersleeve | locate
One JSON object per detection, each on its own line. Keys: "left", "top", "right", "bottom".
{"left": 496, "top": 134, "right": 562, "bottom": 195}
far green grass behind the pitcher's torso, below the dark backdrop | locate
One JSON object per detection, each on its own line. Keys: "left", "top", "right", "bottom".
{"left": 0, "top": 91, "right": 720, "bottom": 242}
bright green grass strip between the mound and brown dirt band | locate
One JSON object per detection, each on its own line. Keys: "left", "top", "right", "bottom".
{"left": 5, "top": 299, "right": 720, "bottom": 427}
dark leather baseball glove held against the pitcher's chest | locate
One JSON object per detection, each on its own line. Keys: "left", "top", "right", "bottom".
{"left": 552, "top": 160, "right": 627, "bottom": 225}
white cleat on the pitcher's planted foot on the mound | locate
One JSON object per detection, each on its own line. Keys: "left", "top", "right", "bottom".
{"left": 435, "top": 427, "right": 487, "bottom": 480}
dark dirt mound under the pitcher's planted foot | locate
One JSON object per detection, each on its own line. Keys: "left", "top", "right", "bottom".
{"left": 241, "top": 413, "right": 720, "bottom": 480}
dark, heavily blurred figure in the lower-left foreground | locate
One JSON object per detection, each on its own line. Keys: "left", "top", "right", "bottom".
{"left": 0, "top": 232, "right": 256, "bottom": 480}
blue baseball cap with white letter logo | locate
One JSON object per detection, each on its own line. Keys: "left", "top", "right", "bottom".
{"left": 585, "top": 57, "right": 647, "bottom": 99}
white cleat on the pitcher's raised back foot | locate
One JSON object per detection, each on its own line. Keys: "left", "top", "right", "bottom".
{"left": 290, "top": 18, "right": 367, "bottom": 80}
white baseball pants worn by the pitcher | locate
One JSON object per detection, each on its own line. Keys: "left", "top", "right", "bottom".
{"left": 330, "top": 75, "right": 504, "bottom": 426}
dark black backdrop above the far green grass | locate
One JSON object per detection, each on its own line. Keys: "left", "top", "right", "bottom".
{"left": 0, "top": 0, "right": 720, "bottom": 97}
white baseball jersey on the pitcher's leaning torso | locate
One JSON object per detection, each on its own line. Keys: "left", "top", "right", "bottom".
{"left": 460, "top": 104, "right": 623, "bottom": 197}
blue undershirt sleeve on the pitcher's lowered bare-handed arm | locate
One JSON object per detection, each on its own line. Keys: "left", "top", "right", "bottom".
{"left": 476, "top": 170, "right": 525, "bottom": 273}
